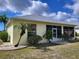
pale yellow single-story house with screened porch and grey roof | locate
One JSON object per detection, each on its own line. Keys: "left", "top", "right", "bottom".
{"left": 7, "top": 16, "right": 76, "bottom": 45}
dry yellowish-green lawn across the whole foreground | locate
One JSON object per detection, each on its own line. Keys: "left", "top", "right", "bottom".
{"left": 0, "top": 42, "right": 79, "bottom": 59}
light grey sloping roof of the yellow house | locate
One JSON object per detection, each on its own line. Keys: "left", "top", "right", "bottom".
{"left": 13, "top": 16, "right": 78, "bottom": 26}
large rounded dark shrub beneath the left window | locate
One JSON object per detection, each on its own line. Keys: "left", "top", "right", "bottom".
{"left": 27, "top": 35, "right": 42, "bottom": 45}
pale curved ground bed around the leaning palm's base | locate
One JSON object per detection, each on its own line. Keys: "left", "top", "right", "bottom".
{"left": 0, "top": 43, "right": 26, "bottom": 50}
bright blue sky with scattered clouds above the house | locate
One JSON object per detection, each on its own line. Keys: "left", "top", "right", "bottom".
{"left": 0, "top": 0, "right": 79, "bottom": 30}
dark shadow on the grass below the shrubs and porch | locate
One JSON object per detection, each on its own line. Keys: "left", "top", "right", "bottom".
{"left": 27, "top": 39, "right": 79, "bottom": 52}
